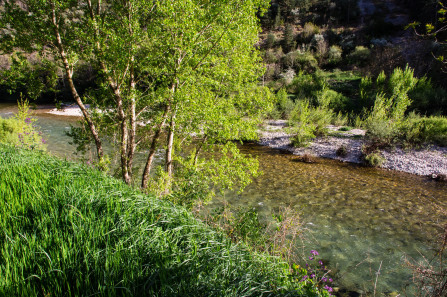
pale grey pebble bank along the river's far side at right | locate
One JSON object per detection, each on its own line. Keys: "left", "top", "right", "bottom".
{"left": 259, "top": 120, "right": 447, "bottom": 176}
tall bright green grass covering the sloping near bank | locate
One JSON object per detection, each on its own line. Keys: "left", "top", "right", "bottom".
{"left": 0, "top": 145, "right": 327, "bottom": 296}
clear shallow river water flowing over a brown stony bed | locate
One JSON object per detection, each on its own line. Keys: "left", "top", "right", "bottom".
{"left": 0, "top": 105, "right": 447, "bottom": 295}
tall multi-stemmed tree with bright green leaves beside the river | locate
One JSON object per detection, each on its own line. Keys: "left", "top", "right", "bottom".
{"left": 2, "top": 0, "right": 270, "bottom": 199}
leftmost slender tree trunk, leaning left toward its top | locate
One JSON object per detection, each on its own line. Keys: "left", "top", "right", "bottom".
{"left": 52, "top": 3, "right": 104, "bottom": 165}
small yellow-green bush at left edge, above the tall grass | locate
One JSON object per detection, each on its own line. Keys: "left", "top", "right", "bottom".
{"left": 0, "top": 100, "right": 45, "bottom": 150}
